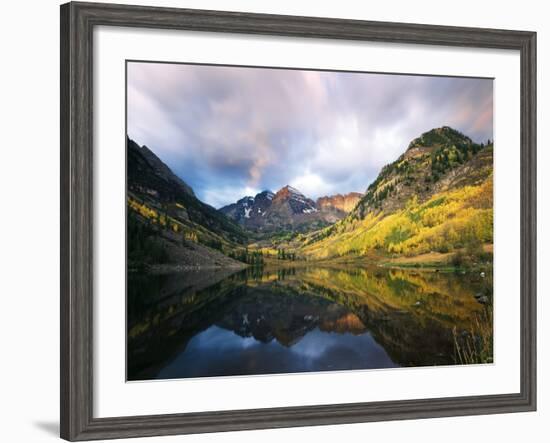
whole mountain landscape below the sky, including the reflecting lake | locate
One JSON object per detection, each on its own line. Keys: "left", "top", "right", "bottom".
{"left": 127, "top": 127, "right": 493, "bottom": 380}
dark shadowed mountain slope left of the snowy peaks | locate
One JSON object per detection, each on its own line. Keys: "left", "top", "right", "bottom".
{"left": 127, "top": 139, "right": 247, "bottom": 269}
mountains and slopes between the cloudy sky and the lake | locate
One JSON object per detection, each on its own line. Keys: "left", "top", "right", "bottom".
{"left": 127, "top": 127, "right": 493, "bottom": 271}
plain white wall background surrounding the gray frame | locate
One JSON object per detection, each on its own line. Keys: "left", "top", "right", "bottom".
{"left": 0, "top": 0, "right": 550, "bottom": 443}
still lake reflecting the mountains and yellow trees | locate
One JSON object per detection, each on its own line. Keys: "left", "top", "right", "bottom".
{"left": 127, "top": 266, "right": 493, "bottom": 380}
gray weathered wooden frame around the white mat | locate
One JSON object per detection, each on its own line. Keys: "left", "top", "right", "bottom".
{"left": 60, "top": 3, "right": 536, "bottom": 441}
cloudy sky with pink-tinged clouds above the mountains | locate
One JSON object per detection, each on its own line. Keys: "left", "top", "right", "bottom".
{"left": 127, "top": 62, "right": 493, "bottom": 208}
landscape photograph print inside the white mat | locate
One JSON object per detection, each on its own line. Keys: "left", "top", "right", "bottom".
{"left": 126, "top": 61, "right": 494, "bottom": 381}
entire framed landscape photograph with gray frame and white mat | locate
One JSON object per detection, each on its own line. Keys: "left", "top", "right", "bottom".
{"left": 61, "top": 3, "right": 536, "bottom": 441}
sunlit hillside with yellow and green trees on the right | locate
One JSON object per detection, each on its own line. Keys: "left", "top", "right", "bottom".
{"left": 299, "top": 127, "right": 493, "bottom": 262}
